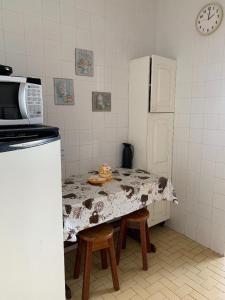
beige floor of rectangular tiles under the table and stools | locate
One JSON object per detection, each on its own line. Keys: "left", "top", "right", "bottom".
{"left": 66, "top": 227, "right": 225, "bottom": 300}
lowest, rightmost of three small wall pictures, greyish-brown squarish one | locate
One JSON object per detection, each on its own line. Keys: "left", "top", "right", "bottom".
{"left": 92, "top": 92, "right": 111, "bottom": 112}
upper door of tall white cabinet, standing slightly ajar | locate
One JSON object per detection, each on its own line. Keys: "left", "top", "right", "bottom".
{"left": 150, "top": 55, "right": 176, "bottom": 112}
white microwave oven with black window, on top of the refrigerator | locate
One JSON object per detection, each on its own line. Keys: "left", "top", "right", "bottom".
{"left": 0, "top": 76, "right": 43, "bottom": 126}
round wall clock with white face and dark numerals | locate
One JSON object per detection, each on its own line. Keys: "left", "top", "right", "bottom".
{"left": 196, "top": 2, "right": 223, "bottom": 35}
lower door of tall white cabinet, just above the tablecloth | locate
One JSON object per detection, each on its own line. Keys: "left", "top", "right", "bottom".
{"left": 147, "top": 113, "right": 173, "bottom": 178}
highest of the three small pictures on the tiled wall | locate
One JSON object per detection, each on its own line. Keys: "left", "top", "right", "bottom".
{"left": 75, "top": 48, "right": 94, "bottom": 76}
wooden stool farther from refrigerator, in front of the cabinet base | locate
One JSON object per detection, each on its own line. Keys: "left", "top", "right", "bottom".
{"left": 116, "top": 209, "right": 151, "bottom": 271}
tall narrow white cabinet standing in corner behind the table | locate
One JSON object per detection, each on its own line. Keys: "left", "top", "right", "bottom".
{"left": 129, "top": 55, "right": 176, "bottom": 226}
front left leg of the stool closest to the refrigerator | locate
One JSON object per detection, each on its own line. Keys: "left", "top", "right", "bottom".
{"left": 82, "top": 242, "right": 92, "bottom": 300}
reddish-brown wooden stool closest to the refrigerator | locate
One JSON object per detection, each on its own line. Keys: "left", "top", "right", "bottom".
{"left": 74, "top": 224, "right": 120, "bottom": 300}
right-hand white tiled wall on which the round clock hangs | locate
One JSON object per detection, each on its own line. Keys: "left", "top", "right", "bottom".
{"left": 156, "top": 0, "right": 225, "bottom": 254}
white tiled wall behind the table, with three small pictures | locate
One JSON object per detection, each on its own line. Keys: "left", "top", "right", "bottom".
{"left": 0, "top": 0, "right": 154, "bottom": 176}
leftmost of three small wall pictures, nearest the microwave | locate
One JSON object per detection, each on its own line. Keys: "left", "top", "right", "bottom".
{"left": 54, "top": 78, "right": 74, "bottom": 105}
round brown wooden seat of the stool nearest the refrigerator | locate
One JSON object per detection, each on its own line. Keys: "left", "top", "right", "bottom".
{"left": 79, "top": 224, "right": 113, "bottom": 243}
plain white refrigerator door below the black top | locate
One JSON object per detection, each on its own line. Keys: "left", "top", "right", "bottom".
{"left": 0, "top": 134, "right": 65, "bottom": 300}
